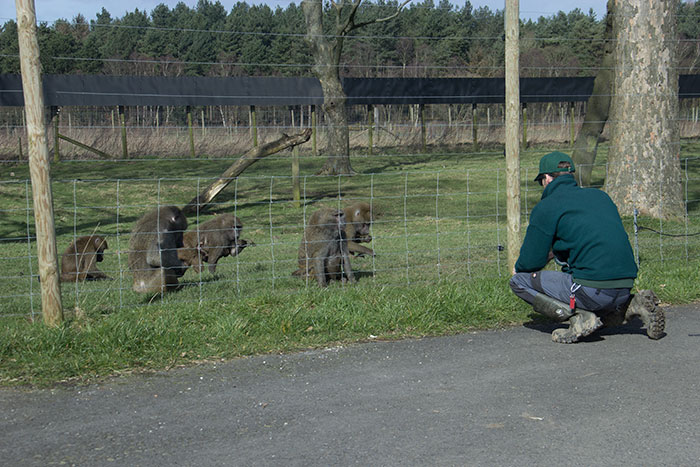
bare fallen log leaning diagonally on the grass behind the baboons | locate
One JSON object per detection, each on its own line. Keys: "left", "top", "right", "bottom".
{"left": 182, "top": 128, "right": 311, "bottom": 215}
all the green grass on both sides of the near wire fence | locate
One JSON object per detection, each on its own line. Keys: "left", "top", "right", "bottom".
{"left": 0, "top": 142, "right": 700, "bottom": 386}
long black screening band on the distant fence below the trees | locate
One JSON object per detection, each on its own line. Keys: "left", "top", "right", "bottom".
{"left": 0, "top": 74, "right": 700, "bottom": 107}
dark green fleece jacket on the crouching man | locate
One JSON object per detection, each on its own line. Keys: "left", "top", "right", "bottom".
{"left": 515, "top": 174, "right": 637, "bottom": 288}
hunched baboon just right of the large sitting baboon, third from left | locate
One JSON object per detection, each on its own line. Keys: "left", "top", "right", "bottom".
{"left": 177, "top": 214, "right": 252, "bottom": 274}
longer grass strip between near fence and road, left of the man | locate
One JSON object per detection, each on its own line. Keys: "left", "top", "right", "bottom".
{"left": 0, "top": 280, "right": 527, "bottom": 385}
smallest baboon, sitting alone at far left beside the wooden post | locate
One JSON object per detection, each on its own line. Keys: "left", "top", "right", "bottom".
{"left": 61, "top": 235, "right": 111, "bottom": 282}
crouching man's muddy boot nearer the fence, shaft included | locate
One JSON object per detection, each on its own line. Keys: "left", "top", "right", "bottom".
{"left": 532, "top": 293, "right": 603, "bottom": 344}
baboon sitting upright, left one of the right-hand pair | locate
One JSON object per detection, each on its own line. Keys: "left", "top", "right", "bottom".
{"left": 292, "top": 208, "right": 355, "bottom": 287}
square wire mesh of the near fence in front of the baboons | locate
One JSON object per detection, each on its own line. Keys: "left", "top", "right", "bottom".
{"left": 0, "top": 154, "right": 700, "bottom": 318}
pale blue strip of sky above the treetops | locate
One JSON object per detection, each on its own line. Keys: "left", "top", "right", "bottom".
{"left": 0, "top": 0, "right": 606, "bottom": 24}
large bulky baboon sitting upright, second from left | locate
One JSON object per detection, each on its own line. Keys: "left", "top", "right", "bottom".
{"left": 129, "top": 206, "right": 187, "bottom": 293}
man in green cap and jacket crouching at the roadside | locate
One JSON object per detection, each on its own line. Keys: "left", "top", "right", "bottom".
{"left": 510, "top": 151, "right": 665, "bottom": 344}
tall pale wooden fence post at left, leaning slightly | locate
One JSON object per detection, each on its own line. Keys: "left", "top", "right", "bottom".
{"left": 15, "top": 0, "right": 63, "bottom": 326}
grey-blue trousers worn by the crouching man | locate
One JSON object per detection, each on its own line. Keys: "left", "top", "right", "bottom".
{"left": 510, "top": 271, "right": 631, "bottom": 315}
